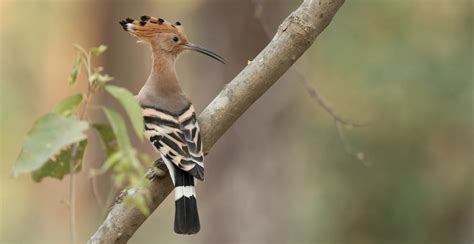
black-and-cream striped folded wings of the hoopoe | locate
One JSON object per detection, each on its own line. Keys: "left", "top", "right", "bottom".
{"left": 143, "top": 105, "right": 204, "bottom": 180}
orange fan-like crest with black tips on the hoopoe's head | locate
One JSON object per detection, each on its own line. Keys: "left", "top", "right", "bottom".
{"left": 120, "top": 15, "right": 187, "bottom": 40}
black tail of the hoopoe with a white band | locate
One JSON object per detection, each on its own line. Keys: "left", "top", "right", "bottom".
{"left": 174, "top": 168, "right": 201, "bottom": 235}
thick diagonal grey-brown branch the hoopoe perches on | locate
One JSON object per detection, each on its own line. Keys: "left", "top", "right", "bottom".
{"left": 89, "top": 0, "right": 344, "bottom": 243}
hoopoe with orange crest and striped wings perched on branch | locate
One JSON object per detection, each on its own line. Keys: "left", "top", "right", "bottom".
{"left": 120, "top": 16, "right": 224, "bottom": 234}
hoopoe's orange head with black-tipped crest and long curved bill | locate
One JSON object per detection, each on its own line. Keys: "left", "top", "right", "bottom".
{"left": 120, "top": 15, "right": 225, "bottom": 63}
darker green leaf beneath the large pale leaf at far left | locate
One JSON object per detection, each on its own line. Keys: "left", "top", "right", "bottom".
{"left": 31, "top": 140, "right": 87, "bottom": 182}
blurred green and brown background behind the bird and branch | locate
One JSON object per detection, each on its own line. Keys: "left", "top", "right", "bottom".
{"left": 0, "top": 0, "right": 474, "bottom": 243}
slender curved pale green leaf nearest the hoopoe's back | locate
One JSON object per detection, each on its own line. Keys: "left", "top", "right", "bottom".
{"left": 105, "top": 85, "right": 144, "bottom": 139}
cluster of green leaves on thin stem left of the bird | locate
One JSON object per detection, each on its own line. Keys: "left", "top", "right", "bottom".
{"left": 14, "top": 45, "right": 150, "bottom": 214}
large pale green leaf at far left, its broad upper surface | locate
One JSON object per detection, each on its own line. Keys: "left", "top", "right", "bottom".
{"left": 13, "top": 113, "right": 89, "bottom": 176}
